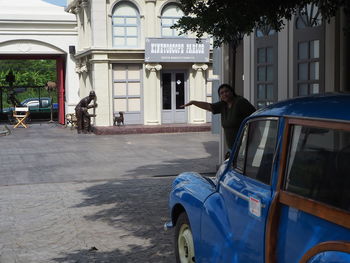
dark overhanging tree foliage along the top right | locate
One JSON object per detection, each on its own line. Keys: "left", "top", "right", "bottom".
{"left": 174, "top": 0, "right": 350, "bottom": 46}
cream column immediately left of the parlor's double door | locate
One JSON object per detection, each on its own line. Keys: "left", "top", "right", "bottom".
{"left": 144, "top": 64, "right": 162, "bottom": 125}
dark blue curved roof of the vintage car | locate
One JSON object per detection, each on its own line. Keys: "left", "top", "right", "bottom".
{"left": 252, "top": 93, "right": 350, "bottom": 121}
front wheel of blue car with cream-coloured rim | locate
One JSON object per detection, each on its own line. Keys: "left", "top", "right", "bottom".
{"left": 175, "top": 212, "right": 195, "bottom": 263}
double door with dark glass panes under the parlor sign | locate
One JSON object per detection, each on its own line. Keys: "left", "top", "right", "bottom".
{"left": 161, "top": 71, "right": 187, "bottom": 123}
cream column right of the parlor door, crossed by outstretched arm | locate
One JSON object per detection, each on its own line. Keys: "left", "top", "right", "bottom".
{"left": 188, "top": 64, "right": 208, "bottom": 124}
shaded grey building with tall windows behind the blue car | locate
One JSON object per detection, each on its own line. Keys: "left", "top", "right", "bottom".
{"left": 223, "top": 4, "right": 350, "bottom": 108}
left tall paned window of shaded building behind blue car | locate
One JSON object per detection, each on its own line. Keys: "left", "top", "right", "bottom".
{"left": 255, "top": 26, "right": 277, "bottom": 109}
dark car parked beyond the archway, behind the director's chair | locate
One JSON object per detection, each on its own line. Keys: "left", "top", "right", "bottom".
{"left": 3, "top": 97, "right": 58, "bottom": 119}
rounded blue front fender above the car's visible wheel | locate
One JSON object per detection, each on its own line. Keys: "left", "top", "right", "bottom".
{"left": 169, "top": 172, "right": 216, "bottom": 255}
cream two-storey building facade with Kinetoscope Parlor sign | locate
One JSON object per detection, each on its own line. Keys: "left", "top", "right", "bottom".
{"left": 66, "top": 0, "right": 216, "bottom": 126}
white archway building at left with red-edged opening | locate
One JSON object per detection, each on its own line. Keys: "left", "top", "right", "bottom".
{"left": 0, "top": 0, "right": 79, "bottom": 124}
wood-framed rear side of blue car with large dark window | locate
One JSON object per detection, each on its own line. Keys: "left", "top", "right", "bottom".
{"left": 271, "top": 118, "right": 350, "bottom": 263}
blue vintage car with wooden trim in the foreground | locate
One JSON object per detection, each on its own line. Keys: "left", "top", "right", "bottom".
{"left": 164, "top": 94, "right": 350, "bottom": 263}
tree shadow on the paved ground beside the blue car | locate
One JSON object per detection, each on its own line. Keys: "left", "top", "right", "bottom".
{"left": 53, "top": 141, "right": 218, "bottom": 263}
